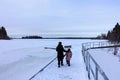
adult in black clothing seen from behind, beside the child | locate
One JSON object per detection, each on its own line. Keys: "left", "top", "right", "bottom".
{"left": 56, "top": 42, "right": 66, "bottom": 67}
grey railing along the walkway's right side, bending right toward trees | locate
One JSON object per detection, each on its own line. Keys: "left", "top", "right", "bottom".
{"left": 82, "top": 41, "right": 120, "bottom": 80}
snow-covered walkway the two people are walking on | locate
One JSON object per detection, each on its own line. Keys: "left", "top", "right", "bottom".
{"left": 32, "top": 44, "right": 88, "bottom": 80}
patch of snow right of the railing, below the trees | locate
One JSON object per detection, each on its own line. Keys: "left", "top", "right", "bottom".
{"left": 89, "top": 48, "right": 120, "bottom": 80}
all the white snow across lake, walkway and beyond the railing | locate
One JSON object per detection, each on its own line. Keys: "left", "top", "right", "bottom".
{"left": 0, "top": 39, "right": 120, "bottom": 80}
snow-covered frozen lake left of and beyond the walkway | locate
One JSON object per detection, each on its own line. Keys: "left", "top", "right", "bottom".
{"left": 0, "top": 39, "right": 90, "bottom": 80}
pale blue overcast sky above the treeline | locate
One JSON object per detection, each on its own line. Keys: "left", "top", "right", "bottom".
{"left": 0, "top": 0, "right": 120, "bottom": 36}
